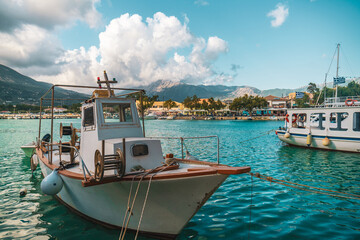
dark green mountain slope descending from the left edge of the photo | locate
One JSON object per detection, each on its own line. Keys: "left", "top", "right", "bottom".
{"left": 0, "top": 64, "right": 87, "bottom": 105}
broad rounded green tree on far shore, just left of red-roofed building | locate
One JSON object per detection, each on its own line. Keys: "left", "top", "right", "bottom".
{"left": 230, "top": 94, "right": 268, "bottom": 116}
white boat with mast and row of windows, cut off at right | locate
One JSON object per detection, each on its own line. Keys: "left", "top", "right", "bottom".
{"left": 276, "top": 44, "right": 360, "bottom": 152}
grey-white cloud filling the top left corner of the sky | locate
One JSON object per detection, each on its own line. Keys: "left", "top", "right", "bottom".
{"left": 0, "top": 0, "right": 101, "bottom": 32}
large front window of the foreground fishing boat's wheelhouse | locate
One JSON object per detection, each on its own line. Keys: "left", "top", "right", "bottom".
{"left": 102, "top": 103, "right": 133, "bottom": 123}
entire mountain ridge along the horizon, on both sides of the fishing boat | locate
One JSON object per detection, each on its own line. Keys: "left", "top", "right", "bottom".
{"left": 0, "top": 64, "right": 312, "bottom": 105}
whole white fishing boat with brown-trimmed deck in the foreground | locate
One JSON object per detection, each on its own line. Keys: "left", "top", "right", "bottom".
{"left": 32, "top": 72, "right": 250, "bottom": 238}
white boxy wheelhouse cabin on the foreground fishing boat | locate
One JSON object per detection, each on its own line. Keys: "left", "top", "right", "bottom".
{"left": 80, "top": 98, "right": 163, "bottom": 176}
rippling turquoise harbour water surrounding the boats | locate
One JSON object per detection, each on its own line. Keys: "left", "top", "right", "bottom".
{"left": 0, "top": 120, "right": 360, "bottom": 239}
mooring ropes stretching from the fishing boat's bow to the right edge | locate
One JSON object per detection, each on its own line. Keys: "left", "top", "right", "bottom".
{"left": 248, "top": 172, "right": 360, "bottom": 200}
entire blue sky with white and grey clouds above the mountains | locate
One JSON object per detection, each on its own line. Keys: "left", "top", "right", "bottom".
{"left": 0, "top": 0, "right": 360, "bottom": 90}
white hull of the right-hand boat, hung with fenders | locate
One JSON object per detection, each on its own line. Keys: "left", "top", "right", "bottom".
{"left": 276, "top": 130, "right": 360, "bottom": 152}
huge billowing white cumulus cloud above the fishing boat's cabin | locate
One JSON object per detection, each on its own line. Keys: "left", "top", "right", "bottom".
{"left": 27, "top": 12, "right": 231, "bottom": 86}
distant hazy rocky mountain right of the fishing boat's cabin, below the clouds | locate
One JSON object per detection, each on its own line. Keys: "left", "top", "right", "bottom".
{"left": 141, "top": 80, "right": 261, "bottom": 102}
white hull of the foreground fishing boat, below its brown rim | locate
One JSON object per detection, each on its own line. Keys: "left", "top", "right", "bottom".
{"left": 40, "top": 161, "right": 228, "bottom": 238}
